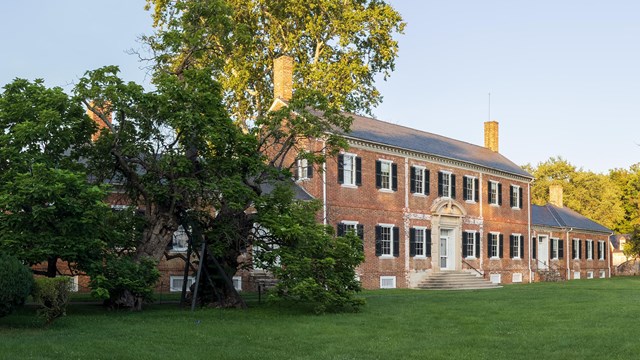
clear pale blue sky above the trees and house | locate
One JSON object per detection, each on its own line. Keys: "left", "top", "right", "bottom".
{"left": 0, "top": 0, "right": 640, "bottom": 172}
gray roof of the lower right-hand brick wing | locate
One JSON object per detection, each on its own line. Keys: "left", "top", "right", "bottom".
{"left": 531, "top": 204, "right": 612, "bottom": 233}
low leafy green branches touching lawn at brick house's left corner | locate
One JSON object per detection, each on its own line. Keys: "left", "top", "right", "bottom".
{"left": 254, "top": 187, "right": 364, "bottom": 313}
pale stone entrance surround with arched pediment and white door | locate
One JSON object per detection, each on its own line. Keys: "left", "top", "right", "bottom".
{"left": 431, "top": 198, "right": 467, "bottom": 272}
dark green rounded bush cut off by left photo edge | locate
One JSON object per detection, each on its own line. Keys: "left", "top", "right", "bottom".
{"left": 0, "top": 254, "right": 33, "bottom": 317}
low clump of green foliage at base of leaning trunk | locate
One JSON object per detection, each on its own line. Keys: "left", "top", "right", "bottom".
{"left": 88, "top": 255, "right": 160, "bottom": 307}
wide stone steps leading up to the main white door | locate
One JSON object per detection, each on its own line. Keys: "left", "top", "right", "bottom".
{"left": 417, "top": 271, "right": 502, "bottom": 290}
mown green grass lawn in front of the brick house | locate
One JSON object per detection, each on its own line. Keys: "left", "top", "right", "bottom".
{"left": 0, "top": 278, "right": 640, "bottom": 359}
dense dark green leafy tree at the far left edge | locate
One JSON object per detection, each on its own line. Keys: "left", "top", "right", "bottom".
{"left": 0, "top": 79, "right": 109, "bottom": 277}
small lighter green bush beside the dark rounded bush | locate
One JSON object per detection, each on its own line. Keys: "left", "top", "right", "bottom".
{"left": 33, "top": 276, "right": 71, "bottom": 325}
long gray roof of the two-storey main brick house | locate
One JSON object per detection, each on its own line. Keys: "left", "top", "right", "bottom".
{"left": 345, "top": 114, "right": 533, "bottom": 179}
